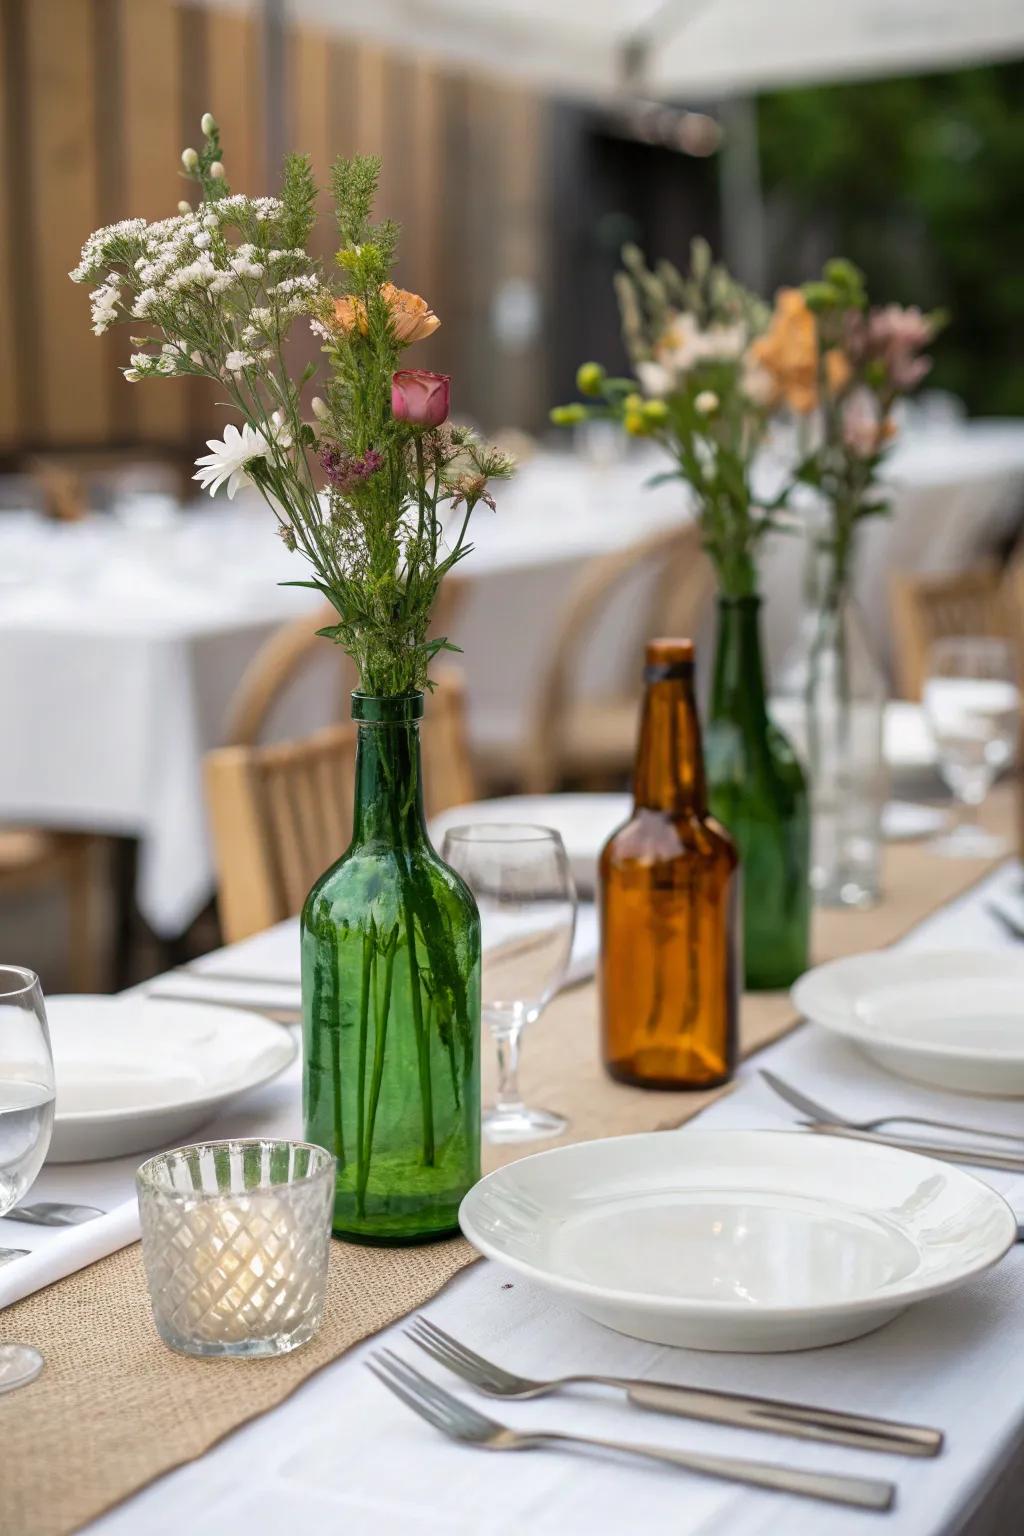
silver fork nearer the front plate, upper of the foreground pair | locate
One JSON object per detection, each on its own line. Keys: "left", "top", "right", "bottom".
{"left": 405, "top": 1316, "right": 943, "bottom": 1456}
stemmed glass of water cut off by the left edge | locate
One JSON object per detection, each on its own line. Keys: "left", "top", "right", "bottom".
{"left": 0, "top": 965, "right": 55, "bottom": 1392}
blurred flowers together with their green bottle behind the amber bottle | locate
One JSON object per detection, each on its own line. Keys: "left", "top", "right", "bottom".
{"left": 551, "top": 240, "right": 809, "bottom": 988}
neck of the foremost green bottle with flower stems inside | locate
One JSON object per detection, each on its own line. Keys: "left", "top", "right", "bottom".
{"left": 352, "top": 703, "right": 427, "bottom": 848}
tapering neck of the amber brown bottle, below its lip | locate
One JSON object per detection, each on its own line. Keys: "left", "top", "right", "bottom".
{"left": 633, "top": 676, "right": 708, "bottom": 816}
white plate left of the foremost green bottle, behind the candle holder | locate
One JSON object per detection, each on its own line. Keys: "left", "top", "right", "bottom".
{"left": 46, "top": 995, "right": 298, "bottom": 1163}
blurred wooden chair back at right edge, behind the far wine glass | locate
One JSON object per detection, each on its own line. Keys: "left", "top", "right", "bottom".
{"left": 892, "top": 565, "right": 1021, "bottom": 699}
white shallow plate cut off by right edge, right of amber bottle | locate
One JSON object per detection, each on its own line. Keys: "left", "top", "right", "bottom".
{"left": 791, "top": 949, "right": 1024, "bottom": 1098}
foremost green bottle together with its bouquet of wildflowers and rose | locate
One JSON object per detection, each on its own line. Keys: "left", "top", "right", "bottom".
{"left": 71, "top": 114, "right": 513, "bottom": 1243}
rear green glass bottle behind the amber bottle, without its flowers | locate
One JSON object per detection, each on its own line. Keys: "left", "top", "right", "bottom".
{"left": 705, "top": 596, "right": 811, "bottom": 991}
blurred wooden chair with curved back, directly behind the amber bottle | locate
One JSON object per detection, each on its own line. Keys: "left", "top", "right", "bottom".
{"left": 522, "top": 522, "right": 714, "bottom": 794}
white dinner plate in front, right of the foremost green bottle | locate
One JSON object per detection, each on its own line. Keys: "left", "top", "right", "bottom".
{"left": 459, "top": 1130, "right": 1016, "bottom": 1353}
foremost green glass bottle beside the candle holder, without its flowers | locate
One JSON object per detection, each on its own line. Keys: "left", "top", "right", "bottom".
{"left": 301, "top": 694, "right": 481, "bottom": 1244}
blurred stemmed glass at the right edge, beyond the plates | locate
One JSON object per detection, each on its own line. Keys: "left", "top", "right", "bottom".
{"left": 924, "top": 636, "right": 1021, "bottom": 859}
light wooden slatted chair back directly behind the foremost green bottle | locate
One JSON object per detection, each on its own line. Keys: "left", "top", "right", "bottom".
{"left": 206, "top": 675, "right": 473, "bottom": 943}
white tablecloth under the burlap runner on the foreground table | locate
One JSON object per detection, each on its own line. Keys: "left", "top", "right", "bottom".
{"left": 0, "top": 865, "right": 1024, "bottom": 1536}
